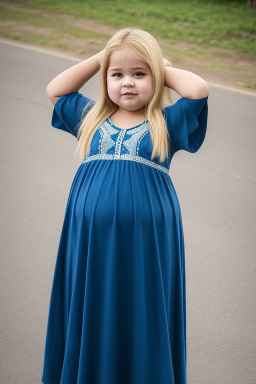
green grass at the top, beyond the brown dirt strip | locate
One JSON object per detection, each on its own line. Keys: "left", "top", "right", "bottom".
{"left": 5, "top": 0, "right": 256, "bottom": 55}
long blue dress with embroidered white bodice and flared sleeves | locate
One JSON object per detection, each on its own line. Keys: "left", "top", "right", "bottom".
{"left": 42, "top": 92, "right": 208, "bottom": 384}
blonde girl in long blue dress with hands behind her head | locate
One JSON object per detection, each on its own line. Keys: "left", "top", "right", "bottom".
{"left": 42, "top": 28, "right": 209, "bottom": 384}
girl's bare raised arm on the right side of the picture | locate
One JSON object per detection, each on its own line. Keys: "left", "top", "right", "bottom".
{"left": 164, "top": 60, "right": 209, "bottom": 99}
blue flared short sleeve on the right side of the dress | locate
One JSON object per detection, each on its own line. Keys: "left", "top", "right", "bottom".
{"left": 163, "top": 97, "right": 208, "bottom": 154}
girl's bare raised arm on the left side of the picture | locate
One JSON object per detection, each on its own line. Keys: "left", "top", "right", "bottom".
{"left": 46, "top": 50, "right": 104, "bottom": 105}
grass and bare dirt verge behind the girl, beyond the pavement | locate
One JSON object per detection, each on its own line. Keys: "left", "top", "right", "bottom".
{"left": 0, "top": 0, "right": 256, "bottom": 92}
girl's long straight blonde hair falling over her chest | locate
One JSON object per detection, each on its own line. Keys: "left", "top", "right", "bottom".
{"left": 76, "top": 28, "right": 172, "bottom": 162}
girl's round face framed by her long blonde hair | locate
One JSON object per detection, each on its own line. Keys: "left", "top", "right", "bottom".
{"left": 107, "top": 47, "right": 153, "bottom": 112}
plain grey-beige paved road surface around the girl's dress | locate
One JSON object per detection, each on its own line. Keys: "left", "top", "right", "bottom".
{"left": 0, "top": 42, "right": 256, "bottom": 384}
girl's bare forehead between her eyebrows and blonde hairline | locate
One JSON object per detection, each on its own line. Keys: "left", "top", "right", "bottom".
{"left": 109, "top": 47, "right": 149, "bottom": 68}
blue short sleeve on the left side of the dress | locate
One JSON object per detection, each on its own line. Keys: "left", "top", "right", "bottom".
{"left": 52, "top": 92, "right": 95, "bottom": 138}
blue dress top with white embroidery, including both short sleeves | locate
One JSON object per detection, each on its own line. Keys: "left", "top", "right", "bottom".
{"left": 52, "top": 92, "right": 208, "bottom": 174}
